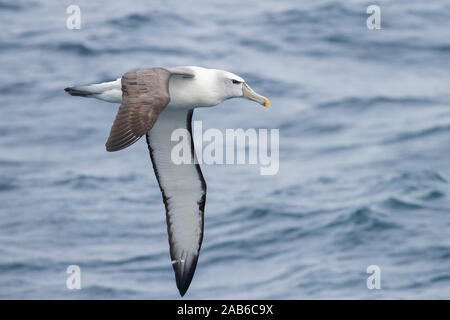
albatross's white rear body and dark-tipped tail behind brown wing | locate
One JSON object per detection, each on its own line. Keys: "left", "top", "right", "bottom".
{"left": 64, "top": 78, "right": 122, "bottom": 103}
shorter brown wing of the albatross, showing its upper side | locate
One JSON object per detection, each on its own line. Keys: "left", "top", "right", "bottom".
{"left": 106, "top": 68, "right": 171, "bottom": 151}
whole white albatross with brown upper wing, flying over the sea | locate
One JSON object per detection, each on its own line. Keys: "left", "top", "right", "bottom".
{"left": 65, "top": 67, "right": 269, "bottom": 296}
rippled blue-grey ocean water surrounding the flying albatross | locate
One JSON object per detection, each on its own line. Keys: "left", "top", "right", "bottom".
{"left": 0, "top": 0, "right": 450, "bottom": 299}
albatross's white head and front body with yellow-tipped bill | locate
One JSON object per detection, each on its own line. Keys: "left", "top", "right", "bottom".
{"left": 169, "top": 67, "right": 269, "bottom": 107}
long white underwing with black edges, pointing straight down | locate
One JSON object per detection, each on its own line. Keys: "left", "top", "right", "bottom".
{"left": 147, "top": 108, "right": 206, "bottom": 296}
